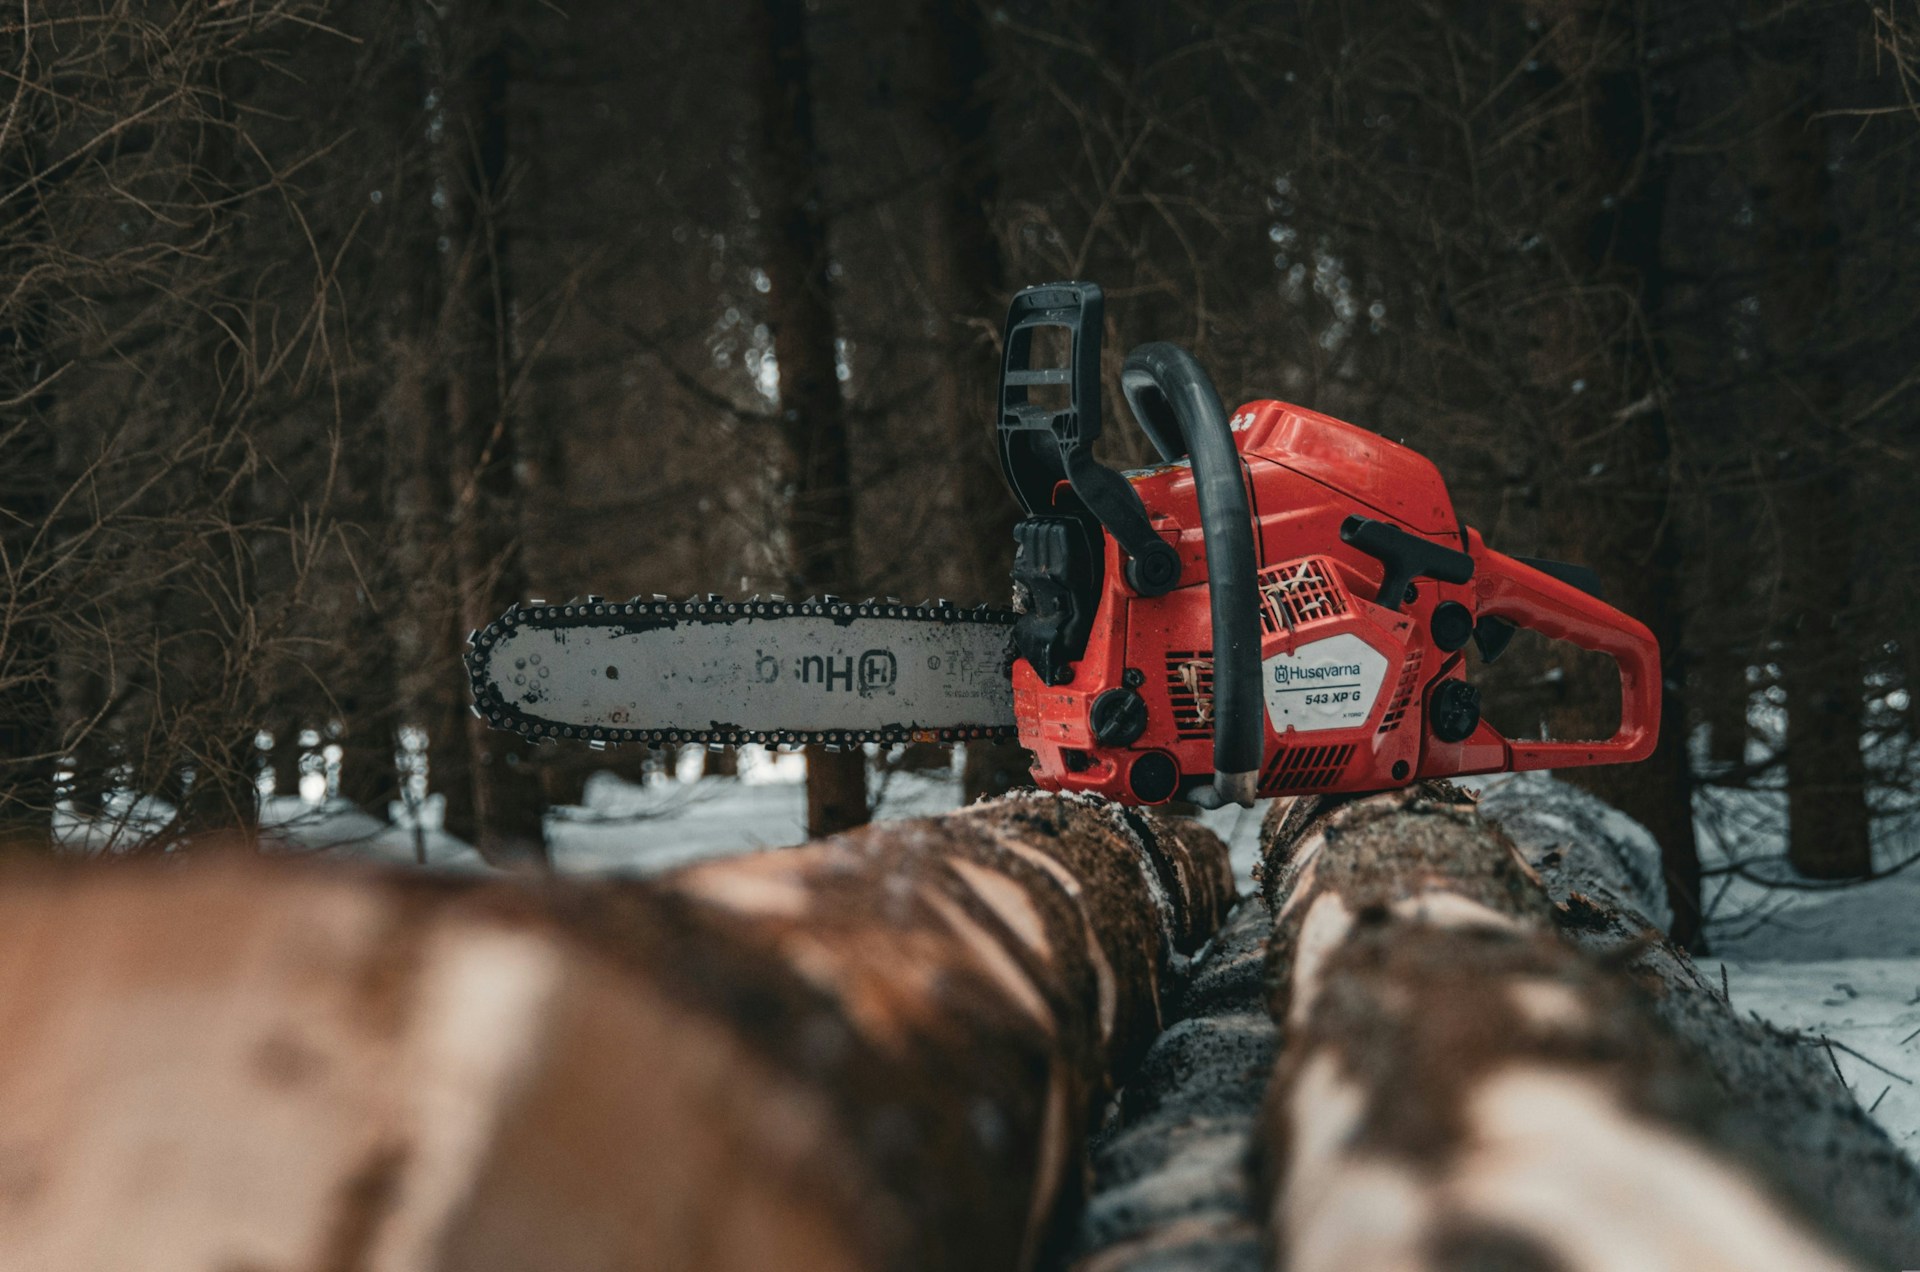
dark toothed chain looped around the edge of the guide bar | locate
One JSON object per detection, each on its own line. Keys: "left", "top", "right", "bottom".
{"left": 467, "top": 592, "right": 1020, "bottom": 749}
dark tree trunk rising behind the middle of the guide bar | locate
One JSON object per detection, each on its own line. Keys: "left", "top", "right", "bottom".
{"left": 751, "top": 0, "right": 868, "bottom": 836}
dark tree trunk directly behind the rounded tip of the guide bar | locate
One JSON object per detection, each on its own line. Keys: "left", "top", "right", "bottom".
{"left": 422, "top": 0, "right": 545, "bottom": 865}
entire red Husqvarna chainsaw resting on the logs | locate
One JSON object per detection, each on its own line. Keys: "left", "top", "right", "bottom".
{"left": 456, "top": 282, "right": 1661, "bottom": 807}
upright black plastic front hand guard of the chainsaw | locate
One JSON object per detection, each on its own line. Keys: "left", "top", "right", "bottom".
{"left": 998, "top": 282, "right": 1181, "bottom": 596}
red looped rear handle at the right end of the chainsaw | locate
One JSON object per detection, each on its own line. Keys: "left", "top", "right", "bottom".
{"left": 1467, "top": 528, "right": 1661, "bottom": 771}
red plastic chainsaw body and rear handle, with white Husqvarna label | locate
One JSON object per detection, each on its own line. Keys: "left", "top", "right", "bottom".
{"left": 1014, "top": 402, "right": 1659, "bottom": 803}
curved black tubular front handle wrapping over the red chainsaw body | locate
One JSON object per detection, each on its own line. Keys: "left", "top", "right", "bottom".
{"left": 1119, "top": 342, "right": 1267, "bottom": 807}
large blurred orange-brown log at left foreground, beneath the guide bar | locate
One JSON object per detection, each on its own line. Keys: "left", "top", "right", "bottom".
{"left": 0, "top": 795, "right": 1233, "bottom": 1272}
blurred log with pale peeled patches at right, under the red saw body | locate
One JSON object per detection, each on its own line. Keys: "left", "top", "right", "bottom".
{"left": 1258, "top": 784, "right": 1920, "bottom": 1272}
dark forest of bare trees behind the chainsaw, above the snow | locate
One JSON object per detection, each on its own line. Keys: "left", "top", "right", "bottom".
{"left": 0, "top": 0, "right": 1920, "bottom": 953}
